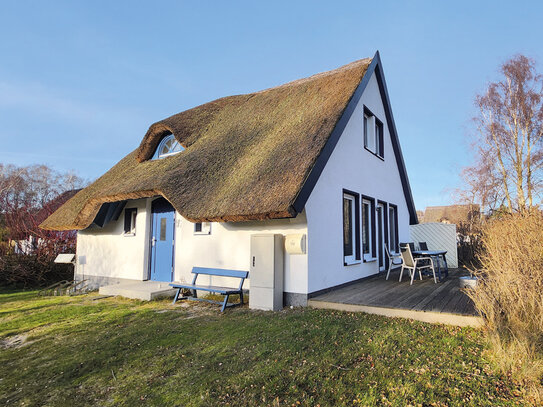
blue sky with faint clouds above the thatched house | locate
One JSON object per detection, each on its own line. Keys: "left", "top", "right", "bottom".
{"left": 0, "top": 0, "right": 543, "bottom": 209}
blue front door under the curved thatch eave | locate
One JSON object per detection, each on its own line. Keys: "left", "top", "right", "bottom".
{"left": 150, "top": 198, "right": 175, "bottom": 281}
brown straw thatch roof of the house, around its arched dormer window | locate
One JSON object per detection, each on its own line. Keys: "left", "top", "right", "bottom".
{"left": 41, "top": 58, "right": 371, "bottom": 230}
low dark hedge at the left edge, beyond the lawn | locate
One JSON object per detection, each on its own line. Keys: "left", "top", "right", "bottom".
{"left": 0, "top": 254, "right": 74, "bottom": 288}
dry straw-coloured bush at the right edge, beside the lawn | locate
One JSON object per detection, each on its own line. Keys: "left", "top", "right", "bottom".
{"left": 469, "top": 212, "right": 543, "bottom": 391}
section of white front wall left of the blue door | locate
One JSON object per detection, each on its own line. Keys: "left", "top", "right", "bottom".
{"left": 76, "top": 199, "right": 151, "bottom": 280}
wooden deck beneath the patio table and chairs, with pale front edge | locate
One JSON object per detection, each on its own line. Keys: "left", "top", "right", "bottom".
{"left": 308, "top": 269, "right": 481, "bottom": 326}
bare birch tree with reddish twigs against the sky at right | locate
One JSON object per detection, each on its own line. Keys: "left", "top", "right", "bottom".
{"left": 462, "top": 55, "right": 543, "bottom": 212}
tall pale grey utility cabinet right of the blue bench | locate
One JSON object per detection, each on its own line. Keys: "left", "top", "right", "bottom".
{"left": 249, "top": 234, "right": 284, "bottom": 311}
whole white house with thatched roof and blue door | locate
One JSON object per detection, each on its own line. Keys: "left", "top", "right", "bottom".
{"left": 41, "top": 53, "right": 417, "bottom": 304}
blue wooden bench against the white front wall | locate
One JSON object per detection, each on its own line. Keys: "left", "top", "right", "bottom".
{"left": 170, "top": 267, "right": 249, "bottom": 312}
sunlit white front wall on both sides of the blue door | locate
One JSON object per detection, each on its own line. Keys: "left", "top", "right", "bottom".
{"left": 76, "top": 199, "right": 308, "bottom": 294}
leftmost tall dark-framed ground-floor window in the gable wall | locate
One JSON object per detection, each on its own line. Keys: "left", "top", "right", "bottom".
{"left": 343, "top": 192, "right": 360, "bottom": 265}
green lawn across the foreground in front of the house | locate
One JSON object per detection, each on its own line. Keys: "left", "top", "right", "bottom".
{"left": 0, "top": 291, "right": 524, "bottom": 406}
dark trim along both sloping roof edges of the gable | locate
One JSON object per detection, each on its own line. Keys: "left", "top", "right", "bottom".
{"left": 292, "top": 51, "right": 418, "bottom": 225}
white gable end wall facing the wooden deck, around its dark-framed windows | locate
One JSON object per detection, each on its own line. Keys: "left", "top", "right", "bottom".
{"left": 306, "top": 74, "right": 409, "bottom": 293}
